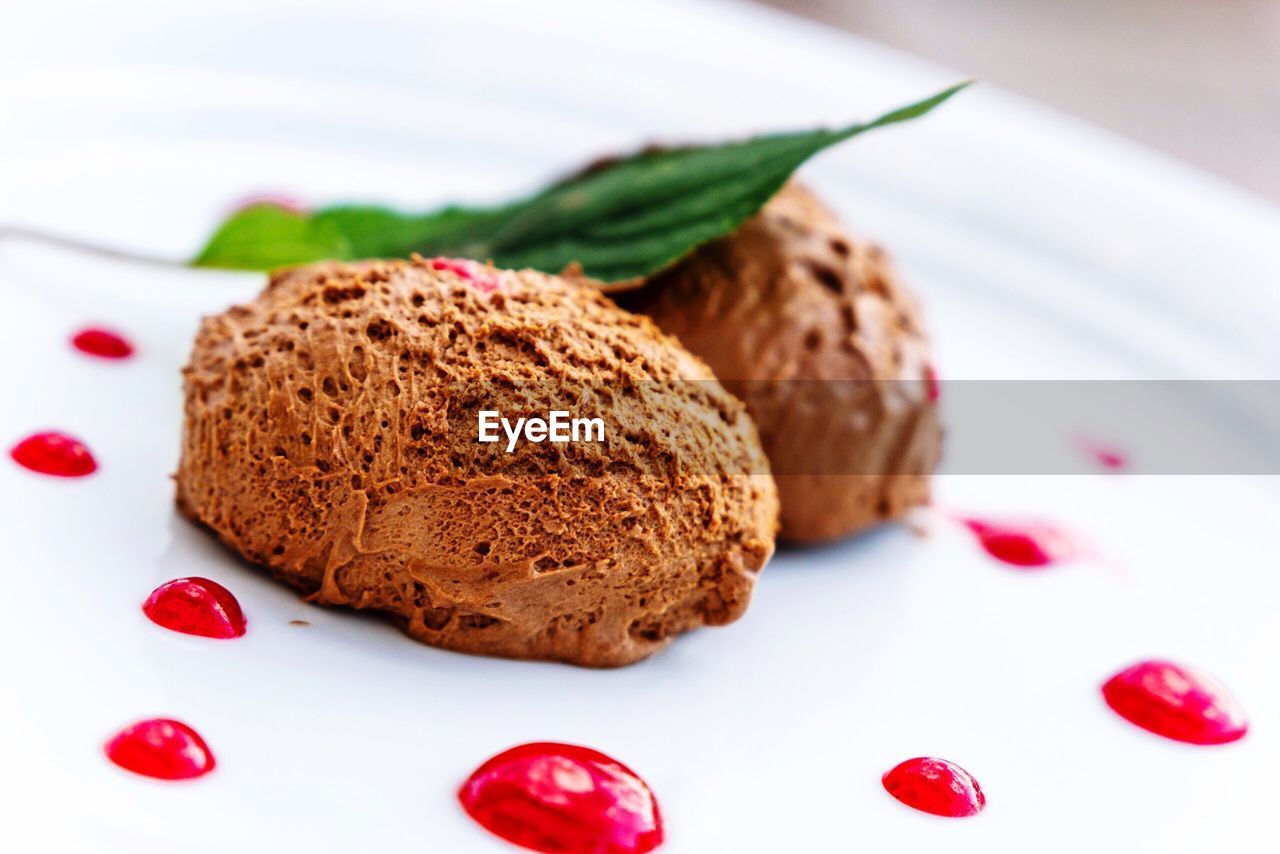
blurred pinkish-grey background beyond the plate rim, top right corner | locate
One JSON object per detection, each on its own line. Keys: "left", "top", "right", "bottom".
{"left": 755, "top": 0, "right": 1280, "bottom": 201}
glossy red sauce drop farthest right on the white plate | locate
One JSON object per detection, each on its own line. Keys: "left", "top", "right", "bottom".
{"left": 1102, "top": 661, "right": 1249, "bottom": 744}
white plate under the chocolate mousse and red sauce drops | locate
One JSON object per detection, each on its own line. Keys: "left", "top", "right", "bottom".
{"left": 0, "top": 0, "right": 1280, "bottom": 851}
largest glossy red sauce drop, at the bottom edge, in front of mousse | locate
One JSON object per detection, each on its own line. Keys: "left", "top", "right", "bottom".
{"left": 458, "top": 741, "right": 663, "bottom": 854}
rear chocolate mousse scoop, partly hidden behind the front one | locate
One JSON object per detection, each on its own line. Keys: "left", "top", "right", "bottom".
{"left": 621, "top": 183, "right": 941, "bottom": 543}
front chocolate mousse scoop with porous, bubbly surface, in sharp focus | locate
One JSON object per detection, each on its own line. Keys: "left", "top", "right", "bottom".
{"left": 177, "top": 257, "right": 777, "bottom": 666}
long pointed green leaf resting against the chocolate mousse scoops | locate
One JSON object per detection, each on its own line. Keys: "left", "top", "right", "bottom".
{"left": 192, "top": 83, "right": 968, "bottom": 282}
